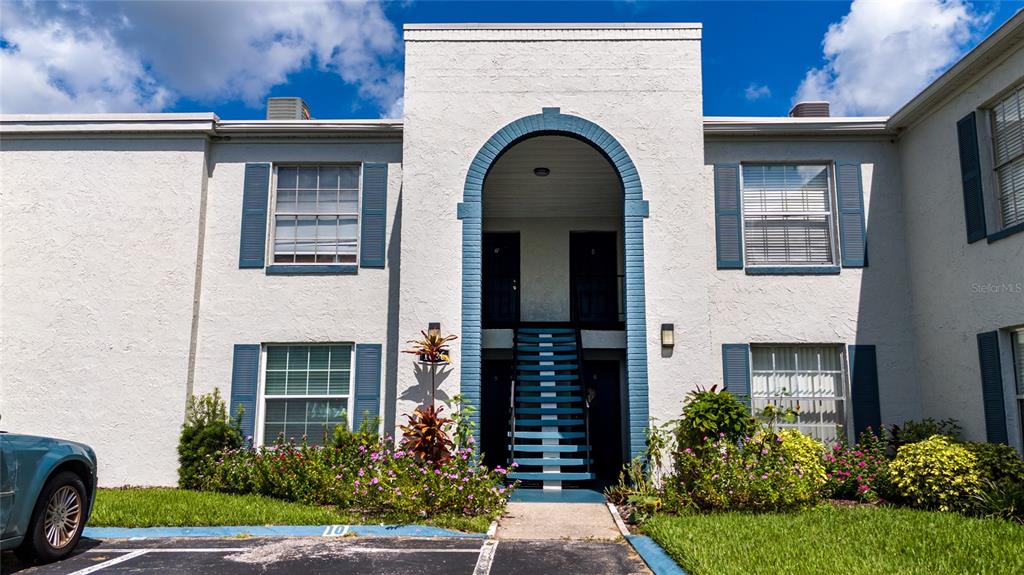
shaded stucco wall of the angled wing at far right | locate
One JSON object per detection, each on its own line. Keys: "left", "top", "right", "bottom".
{"left": 899, "top": 44, "right": 1024, "bottom": 442}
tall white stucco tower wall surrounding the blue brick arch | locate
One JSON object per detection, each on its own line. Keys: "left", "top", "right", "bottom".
{"left": 397, "top": 25, "right": 714, "bottom": 431}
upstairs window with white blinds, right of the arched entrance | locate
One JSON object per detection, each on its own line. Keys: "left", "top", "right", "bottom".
{"left": 742, "top": 164, "right": 836, "bottom": 266}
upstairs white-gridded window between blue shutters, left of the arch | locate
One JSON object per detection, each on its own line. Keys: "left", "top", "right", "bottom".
{"left": 273, "top": 166, "right": 359, "bottom": 264}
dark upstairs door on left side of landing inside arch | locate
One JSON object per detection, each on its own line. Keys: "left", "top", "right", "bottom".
{"left": 482, "top": 231, "right": 519, "bottom": 327}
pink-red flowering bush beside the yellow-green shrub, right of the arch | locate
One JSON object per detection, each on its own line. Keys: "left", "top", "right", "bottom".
{"left": 824, "top": 443, "right": 889, "bottom": 502}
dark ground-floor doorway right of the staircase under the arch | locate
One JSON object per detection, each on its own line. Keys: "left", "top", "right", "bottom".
{"left": 584, "top": 359, "right": 624, "bottom": 485}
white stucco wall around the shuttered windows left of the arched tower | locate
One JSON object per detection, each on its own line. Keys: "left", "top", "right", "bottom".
{"left": 195, "top": 140, "right": 410, "bottom": 444}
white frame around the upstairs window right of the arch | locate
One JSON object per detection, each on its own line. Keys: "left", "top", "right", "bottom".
{"left": 738, "top": 160, "right": 841, "bottom": 268}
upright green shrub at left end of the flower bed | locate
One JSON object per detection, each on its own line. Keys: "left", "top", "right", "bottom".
{"left": 178, "top": 389, "right": 243, "bottom": 489}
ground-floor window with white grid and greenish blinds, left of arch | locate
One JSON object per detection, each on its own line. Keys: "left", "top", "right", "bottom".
{"left": 261, "top": 344, "right": 352, "bottom": 445}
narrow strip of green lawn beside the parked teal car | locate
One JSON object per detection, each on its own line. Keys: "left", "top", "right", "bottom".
{"left": 89, "top": 487, "right": 493, "bottom": 532}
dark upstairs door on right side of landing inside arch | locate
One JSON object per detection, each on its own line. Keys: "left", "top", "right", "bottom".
{"left": 569, "top": 231, "right": 618, "bottom": 327}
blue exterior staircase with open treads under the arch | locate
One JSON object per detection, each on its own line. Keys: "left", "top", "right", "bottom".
{"left": 509, "top": 327, "right": 594, "bottom": 489}
